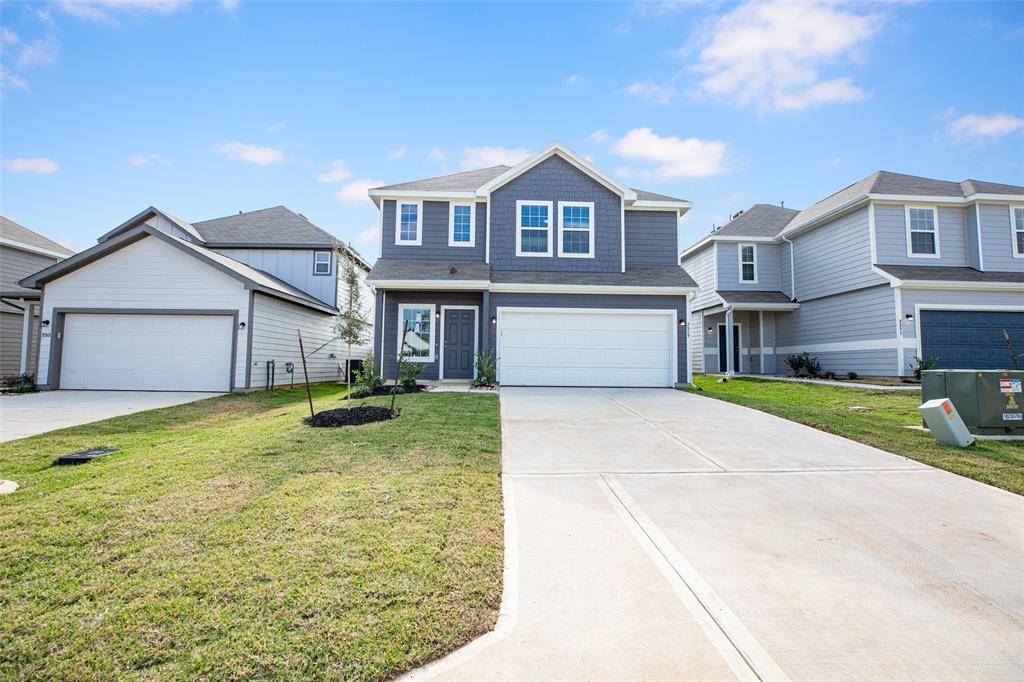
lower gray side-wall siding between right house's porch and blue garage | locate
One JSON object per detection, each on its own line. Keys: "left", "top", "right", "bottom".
{"left": 775, "top": 282, "right": 897, "bottom": 376}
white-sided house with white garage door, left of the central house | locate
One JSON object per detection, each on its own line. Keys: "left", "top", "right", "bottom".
{"left": 20, "top": 206, "right": 373, "bottom": 391}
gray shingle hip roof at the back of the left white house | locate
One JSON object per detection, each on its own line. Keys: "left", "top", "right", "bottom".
{"left": 193, "top": 206, "right": 334, "bottom": 248}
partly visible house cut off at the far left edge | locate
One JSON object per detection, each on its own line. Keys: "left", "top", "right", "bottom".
{"left": 0, "top": 216, "right": 75, "bottom": 377}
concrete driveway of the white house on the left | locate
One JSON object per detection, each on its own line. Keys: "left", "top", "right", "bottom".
{"left": 0, "top": 391, "right": 222, "bottom": 441}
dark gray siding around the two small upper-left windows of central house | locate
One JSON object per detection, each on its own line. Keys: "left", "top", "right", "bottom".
{"left": 381, "top": 200, "right": 487, "bottom": 262}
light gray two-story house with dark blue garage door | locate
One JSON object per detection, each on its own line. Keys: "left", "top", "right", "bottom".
{"left": 681, "top": 171, "right": 1024, "bottom": 376}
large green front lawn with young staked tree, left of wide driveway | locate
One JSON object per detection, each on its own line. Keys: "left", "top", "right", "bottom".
{"left": 0, "top": 386, "right": 503, "bottom": 680}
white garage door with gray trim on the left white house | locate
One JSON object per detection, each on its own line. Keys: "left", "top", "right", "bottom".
{"left": 60, "top": 313, "right": 234, "bottom": 391}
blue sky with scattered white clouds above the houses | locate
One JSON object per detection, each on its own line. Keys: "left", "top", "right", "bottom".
{"left": 0, "top": 0, "right": 1024, "bottom": 260}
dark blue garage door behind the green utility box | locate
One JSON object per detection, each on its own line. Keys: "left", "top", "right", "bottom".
{"left": 921, "top": 310, "right": 1024, "bottom": 370}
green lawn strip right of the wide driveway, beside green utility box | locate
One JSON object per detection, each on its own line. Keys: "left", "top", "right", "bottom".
{"left": 694, "top": 377, "right": 1024, "bottom": 495}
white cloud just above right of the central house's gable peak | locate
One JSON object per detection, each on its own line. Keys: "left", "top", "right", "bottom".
{"left": 611, "top": 128, "right": 728, "bottom": 180}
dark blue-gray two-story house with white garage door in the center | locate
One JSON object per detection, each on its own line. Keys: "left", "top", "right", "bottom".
{"left": 369, "top": 143, "right": 694, "bottom": 386}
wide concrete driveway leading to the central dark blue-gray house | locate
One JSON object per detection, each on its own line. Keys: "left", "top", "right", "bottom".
{"left": 409, "top": 388, "right": 1024, "bottom": 682}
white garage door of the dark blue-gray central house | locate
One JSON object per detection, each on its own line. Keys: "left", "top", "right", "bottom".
{"left": 498, "top": 308, "right": 676, "bottom": 386}
